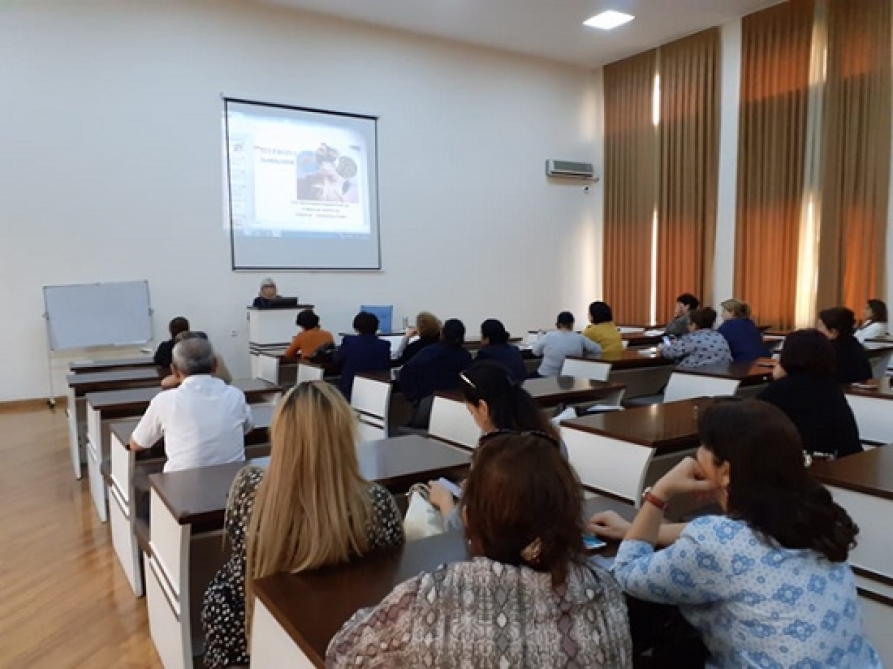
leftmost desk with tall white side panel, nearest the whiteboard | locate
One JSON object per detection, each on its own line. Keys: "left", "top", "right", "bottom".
{"left": 66, "top": 363, "right": 161, "bottom": 479}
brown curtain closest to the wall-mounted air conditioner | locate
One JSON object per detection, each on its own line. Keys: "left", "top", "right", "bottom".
{"left": 604, "top": 50, "right": 656, "bottom": 323}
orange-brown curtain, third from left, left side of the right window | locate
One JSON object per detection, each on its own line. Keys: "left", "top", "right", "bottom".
{"left": 735, "top": 0, "right": 813, "bottom": 328}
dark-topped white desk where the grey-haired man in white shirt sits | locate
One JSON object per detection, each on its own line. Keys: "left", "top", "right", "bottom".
{"left": 105, "top": 404, "right": 276, "bottom": 597}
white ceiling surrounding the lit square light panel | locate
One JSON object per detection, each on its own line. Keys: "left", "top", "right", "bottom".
{"left": 256, "top": 0, "right": 780, "bottom": 67}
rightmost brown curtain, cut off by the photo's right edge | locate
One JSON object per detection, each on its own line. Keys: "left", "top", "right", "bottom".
{"left": 817, "top": 0, "right": 893, "bottom": 314}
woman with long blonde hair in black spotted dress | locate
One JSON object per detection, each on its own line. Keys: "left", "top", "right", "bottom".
{"left": 202, "top": 381, "right": 403, "bottom": 669}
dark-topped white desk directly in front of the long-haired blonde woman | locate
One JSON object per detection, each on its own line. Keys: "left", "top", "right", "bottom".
{"left": 146, "top": 435, "right": 471, "bottom": 669}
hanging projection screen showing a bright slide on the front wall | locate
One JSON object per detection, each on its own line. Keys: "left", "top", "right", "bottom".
{"left": 226, "top": 100, "right": 380, "bottom": 269}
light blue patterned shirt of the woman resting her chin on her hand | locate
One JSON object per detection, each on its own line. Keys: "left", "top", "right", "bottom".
{"left": 614, "top": 516, "right": 883, "bottom": 669}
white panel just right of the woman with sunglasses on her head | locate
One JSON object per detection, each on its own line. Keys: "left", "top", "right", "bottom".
{"left": 561, "top": 425, "right": 654, "bottom": 506}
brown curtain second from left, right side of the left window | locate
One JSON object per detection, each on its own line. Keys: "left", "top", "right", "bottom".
{"left": 657, "top": 28, "right": 720, "bottom": 323}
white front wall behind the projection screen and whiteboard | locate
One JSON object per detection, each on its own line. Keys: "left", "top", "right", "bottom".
{"left": 0, "top": 0, "right": 601, "bottom": 401}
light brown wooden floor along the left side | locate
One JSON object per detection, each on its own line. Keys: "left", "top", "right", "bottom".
{"left": 0, "top": 409, "right": 161, "bottom": 669}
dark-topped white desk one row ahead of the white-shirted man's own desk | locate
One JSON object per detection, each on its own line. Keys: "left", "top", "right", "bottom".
{"left": 86, "top": 379, "right": 281, "bottom": 522}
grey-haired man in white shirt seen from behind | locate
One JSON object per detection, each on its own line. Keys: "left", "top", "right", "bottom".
{"left": 130, "top": 338, "right": 254, "bottom": 472}
